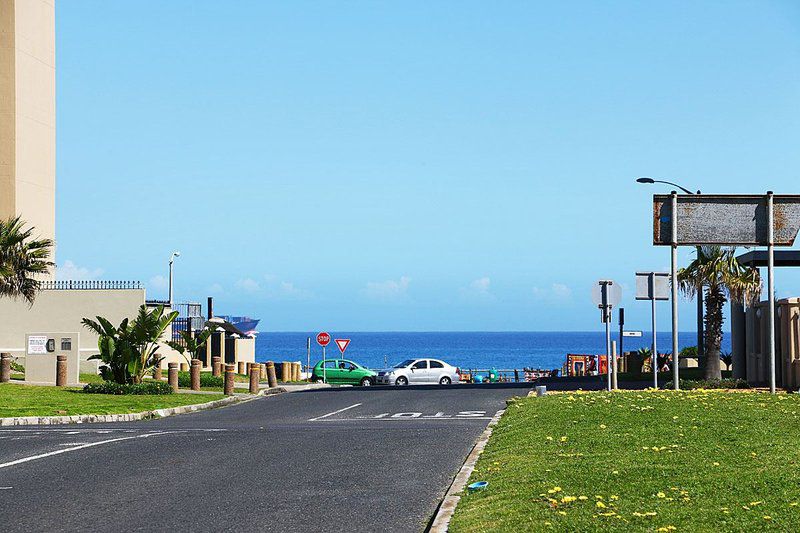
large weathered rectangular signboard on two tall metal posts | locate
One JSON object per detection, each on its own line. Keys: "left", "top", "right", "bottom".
{"left": 653, "top": 191, "right": 800, "bottom": 393}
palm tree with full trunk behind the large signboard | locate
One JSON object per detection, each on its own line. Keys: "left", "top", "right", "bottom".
{"left": 678, "top": 246, "right": 761, "bottom": 379}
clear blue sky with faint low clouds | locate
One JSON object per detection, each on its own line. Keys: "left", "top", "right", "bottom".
{"left": 57, "top": 0, "right": 800, "bottom": 331}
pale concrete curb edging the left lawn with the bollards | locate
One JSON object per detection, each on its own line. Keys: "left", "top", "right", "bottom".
{"left": 0, "top": 387, "right": 332, "bottom": 427}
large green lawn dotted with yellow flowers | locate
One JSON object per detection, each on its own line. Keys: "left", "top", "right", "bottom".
{"left": 451, "top": 391, "right": 800, "bottom": 532}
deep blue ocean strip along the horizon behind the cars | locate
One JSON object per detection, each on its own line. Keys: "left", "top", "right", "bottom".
{"left": 256, "top": 331, "right": 730, "bottom": 369}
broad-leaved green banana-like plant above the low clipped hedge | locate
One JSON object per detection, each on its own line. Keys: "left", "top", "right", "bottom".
{"left": 82, "top": 305, "right": 178, "bottom": 384}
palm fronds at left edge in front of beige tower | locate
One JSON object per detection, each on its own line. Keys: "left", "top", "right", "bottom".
{"left": 0, "top": 216, "right": 53, "bottom": 305}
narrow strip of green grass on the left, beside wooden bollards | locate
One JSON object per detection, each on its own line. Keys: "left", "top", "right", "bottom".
{"left": 0, "top": 383, "right": 224, "bottom": 417}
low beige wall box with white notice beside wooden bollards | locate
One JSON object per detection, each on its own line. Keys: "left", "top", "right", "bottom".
{"left": 25, "top": 332, "right": 80, "bottom": 386}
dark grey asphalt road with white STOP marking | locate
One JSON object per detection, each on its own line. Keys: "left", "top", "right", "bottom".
{"left": 0, "top": 385, "right": 527, "bottom": 532}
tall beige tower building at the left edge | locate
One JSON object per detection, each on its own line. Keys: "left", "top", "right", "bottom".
{"left": 0, "top": 0, "right": 56, "bottom": 258}
